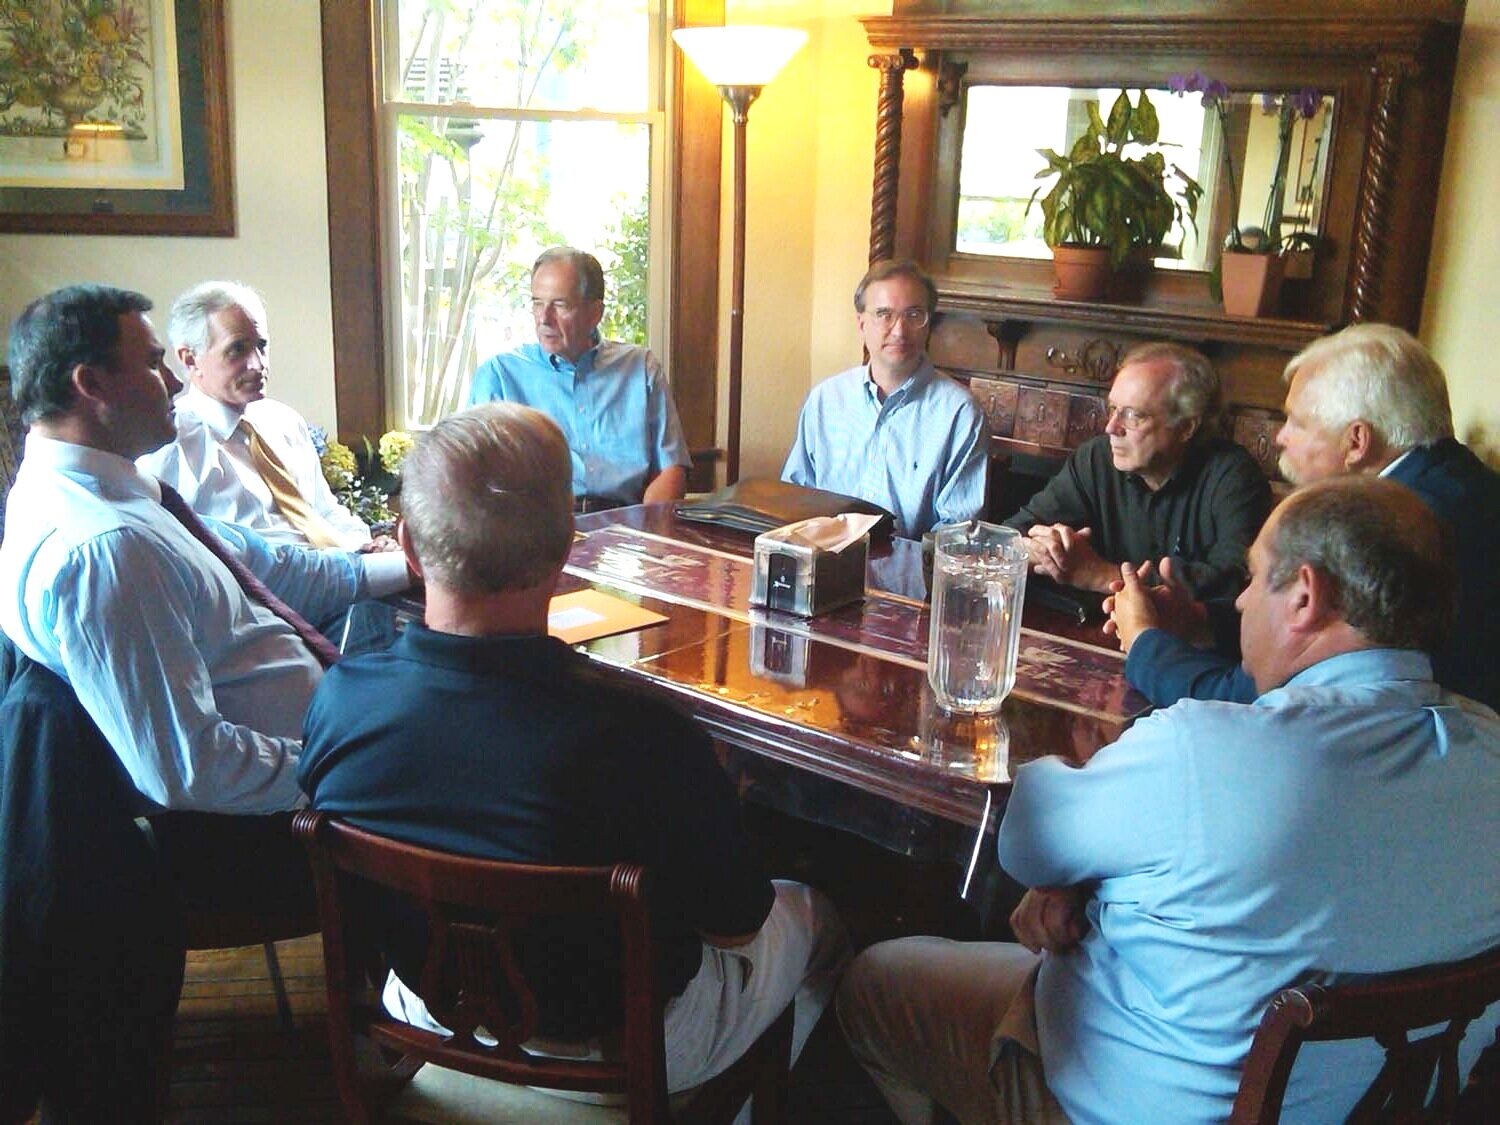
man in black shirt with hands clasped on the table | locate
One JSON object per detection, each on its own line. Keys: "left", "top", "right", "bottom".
{"left": 1005, "top": 344, "right": 1271, "bottom": 597}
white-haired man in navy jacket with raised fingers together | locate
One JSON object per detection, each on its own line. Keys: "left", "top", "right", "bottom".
{"left": 1112, "top": 324, "right": 1500, "bottom": 708}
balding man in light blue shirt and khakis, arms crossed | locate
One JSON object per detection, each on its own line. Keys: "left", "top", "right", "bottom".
{"left": 839, "top": 477, "right": 1500, "bottom": 1125}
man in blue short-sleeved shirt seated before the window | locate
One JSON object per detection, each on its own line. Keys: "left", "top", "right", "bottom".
{"left": 470, "top": 246, "right": 692, "bottom": 512}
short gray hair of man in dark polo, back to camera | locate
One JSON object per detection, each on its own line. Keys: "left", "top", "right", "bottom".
{"left": 401, "top": 402, "right": 573, "bottom": 594}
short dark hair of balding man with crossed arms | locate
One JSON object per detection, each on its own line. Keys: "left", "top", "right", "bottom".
{"left": 1266, "top": 474, "right": 1458, "bottom": 653}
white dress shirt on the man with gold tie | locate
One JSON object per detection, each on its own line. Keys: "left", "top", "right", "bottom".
{"left": 137, "top": 387, "right": 371, "bottom": 551}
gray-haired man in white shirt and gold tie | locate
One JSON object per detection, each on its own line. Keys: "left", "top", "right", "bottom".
{"left": 140, "top": 281, "right": 405, "bottom": 651}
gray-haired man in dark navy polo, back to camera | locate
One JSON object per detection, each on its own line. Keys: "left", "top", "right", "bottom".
{"left": 299, "top": 402, "right": 845, "bottom": 1091}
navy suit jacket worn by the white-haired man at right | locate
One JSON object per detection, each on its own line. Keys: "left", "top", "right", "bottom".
{"left": 1125, "top": 438, "right": 1500, "bottom": 711}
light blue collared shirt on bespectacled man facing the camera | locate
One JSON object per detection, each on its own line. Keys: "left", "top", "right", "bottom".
{"left": 782, "top": 359, "right": 990, "bottom": 539}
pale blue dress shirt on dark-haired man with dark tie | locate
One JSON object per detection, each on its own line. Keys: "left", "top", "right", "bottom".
{"left": 0, "top": 432, "right": 390, "bottom": 813}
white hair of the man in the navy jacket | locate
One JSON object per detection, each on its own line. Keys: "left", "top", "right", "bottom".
{"left": 1284, "top": 324, "right": 1454, "bottom": 453}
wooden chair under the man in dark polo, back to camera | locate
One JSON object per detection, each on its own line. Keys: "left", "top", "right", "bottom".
{"left": 293, "top": 810, "right": 792, "bottom": 1125}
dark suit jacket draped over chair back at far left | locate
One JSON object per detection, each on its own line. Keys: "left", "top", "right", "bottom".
{"left": 0, "top": 635, "right": 183, "bottom": 1122}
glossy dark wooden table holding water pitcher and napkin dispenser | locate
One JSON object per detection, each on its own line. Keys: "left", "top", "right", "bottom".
{"left": 560, "top": 504, "right": 1148, "bottom": 870}
